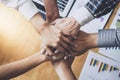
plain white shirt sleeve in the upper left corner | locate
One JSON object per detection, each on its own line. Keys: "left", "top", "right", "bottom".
{"left": 0, "top": 0, "right": 39, "bottom": 20}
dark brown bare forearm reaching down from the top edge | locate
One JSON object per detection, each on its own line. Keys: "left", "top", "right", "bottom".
{"left": 44, "top": 0, "right": 60, "bottom": 22}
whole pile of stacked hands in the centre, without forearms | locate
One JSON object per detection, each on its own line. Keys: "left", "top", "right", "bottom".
{"left": 40, "top": 17, "right": 97, "bottom": 62}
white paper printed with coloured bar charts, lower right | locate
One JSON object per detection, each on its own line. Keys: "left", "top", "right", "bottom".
{"left": 78, "top": 51, "right": 120, "bottom": 80}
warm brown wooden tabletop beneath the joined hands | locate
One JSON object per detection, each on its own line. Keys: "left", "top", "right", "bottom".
{"left": 0, "top": 4, "right": 119, "bottom": 80}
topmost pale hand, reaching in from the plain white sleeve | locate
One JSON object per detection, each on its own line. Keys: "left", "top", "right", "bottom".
{"left": 40, "top": 23, "right": 74, "bottom": 53}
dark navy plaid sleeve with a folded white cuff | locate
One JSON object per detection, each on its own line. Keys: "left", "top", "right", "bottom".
{"left": 72, "top": 0, "right": 120, "bottom": 26}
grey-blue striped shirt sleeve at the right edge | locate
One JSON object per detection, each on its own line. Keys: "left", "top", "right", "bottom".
{"left": 98, "top": 29, "right": 120, "bottom": 47}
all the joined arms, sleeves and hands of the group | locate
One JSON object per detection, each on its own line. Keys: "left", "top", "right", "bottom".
{"left": 0, "top": 0, "right": 120, "bottom": 80}
